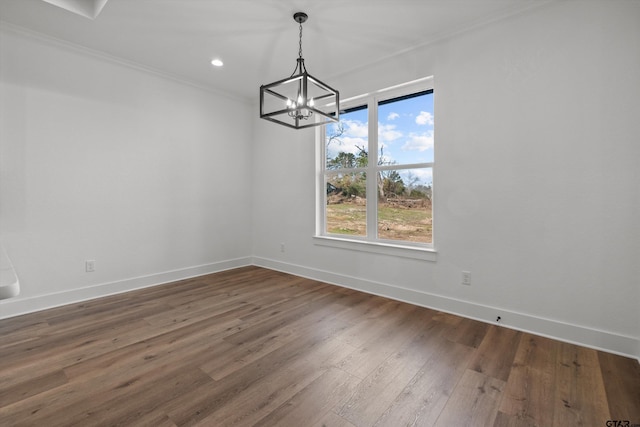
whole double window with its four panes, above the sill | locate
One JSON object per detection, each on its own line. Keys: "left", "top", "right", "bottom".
{"left": 317, "top": 78, "right": 434, "bottom": 258}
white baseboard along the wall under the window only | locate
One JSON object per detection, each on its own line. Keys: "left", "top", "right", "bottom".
{"left": 253, "top": 257, "right": 640, "bottom": 362}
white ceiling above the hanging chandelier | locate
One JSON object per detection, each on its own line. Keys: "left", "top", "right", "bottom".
{"left": 0, "top": 0, "right": 548, "bottom": 98}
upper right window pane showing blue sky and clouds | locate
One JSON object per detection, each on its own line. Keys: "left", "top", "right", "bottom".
{"left": 378, "top": 91, "right": 434, "bottom": 165}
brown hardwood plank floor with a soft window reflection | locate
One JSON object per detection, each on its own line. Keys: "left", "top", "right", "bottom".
{"left": 0, "top": 267, "right": 640, "bottom": 427}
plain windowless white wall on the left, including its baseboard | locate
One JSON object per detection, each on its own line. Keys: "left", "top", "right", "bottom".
{"left": 0, "top": 28, "right": 253, "bottom": 318}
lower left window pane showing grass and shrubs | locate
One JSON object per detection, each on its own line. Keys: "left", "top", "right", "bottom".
{"left": 325, "top": 172, "right": 367, "bottom": 237}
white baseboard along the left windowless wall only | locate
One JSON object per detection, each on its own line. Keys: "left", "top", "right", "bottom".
{"left": 0, "top": 257, "right": 252, "bottom": 319}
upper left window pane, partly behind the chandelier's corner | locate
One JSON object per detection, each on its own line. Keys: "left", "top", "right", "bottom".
{"left": 325, "top": 106, "right": 369, "bottom": 170}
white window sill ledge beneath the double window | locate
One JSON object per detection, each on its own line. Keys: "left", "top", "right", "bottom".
{"left": 313, "top": 236, "right": 437, "bottom": 262}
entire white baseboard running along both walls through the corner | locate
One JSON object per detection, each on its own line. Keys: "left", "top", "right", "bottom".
{"left": 0, "top": 257, "right": 640, "bottom": 362}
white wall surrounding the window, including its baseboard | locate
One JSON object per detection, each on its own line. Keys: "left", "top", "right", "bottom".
{"left": 253, "top": 1, "right": 640, "bottom": 357}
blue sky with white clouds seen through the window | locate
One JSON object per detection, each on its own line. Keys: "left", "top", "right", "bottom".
{"left": 327, "top": 93, "right": 434, "bottom": 184}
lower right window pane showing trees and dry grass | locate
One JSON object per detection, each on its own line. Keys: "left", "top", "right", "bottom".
{"left": 377, "top": 168, "right": 433, "bottom": 243}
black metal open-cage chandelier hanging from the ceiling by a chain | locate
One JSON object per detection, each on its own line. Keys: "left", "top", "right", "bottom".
{"left": 260, "top": 12, "right": 340, "bottom": 129}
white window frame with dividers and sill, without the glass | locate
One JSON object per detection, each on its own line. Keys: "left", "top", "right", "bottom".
{"left": 314, "top": 76, "right": 436, "bottom": 261}
